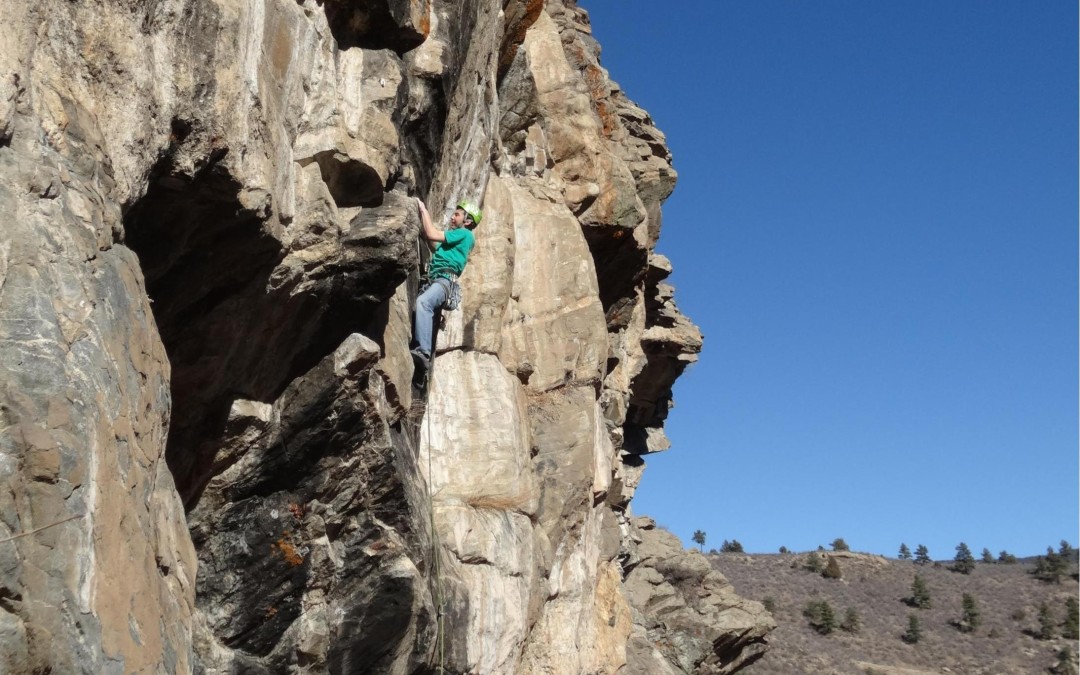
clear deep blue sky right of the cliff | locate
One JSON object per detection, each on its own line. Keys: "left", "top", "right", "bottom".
{"left": 581, "top": 0, "right": 1078, "bottom": 559}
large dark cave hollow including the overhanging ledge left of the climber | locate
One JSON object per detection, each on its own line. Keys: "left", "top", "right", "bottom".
{"left": 124, "top": 143, "right": 416, "bottom": 510}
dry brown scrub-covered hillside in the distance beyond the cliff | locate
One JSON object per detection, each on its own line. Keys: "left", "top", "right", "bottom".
{"left": 708, "top": 552, "right": 1078, "bottom": 675}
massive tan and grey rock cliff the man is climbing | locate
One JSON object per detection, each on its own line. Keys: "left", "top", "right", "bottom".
{"left": 0, "top": 0, "right": 768, "bottom": 674}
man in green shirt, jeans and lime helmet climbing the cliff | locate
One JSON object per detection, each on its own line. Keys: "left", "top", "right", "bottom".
{"left": 413, "top": 198, "right": 483, "bottom": 372}
